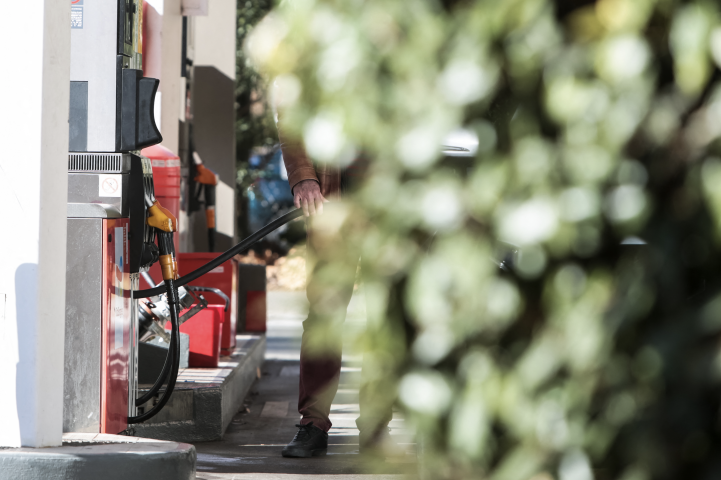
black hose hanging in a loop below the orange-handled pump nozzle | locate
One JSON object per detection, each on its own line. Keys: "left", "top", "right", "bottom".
{"left": 128, "top": 231, "right": 180, "bottom": 424}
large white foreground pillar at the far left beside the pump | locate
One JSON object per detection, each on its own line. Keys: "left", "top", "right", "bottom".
{"left": 0, "top": 0, "right": 70, "bottom": 447}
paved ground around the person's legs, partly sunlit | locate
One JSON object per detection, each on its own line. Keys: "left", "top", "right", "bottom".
{"left": 195, "top": 292, "right": 416, "bottom": 480}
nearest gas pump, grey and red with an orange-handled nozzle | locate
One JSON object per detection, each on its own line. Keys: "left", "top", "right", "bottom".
{"left": 63, "top": 0, "right": 173, "bottom": 433}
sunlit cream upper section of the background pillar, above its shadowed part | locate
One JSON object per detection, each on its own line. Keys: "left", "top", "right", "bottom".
{"left": 194, "top": 0, "right": 236, "bottom": 79}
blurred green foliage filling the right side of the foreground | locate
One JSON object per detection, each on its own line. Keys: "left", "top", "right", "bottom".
{"left": 246, "top": 0, "right": 721, "bottom": 480}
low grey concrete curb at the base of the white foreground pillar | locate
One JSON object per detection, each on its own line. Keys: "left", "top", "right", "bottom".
{"left": 0, "top": 433, "right": 196, "bottom": 480}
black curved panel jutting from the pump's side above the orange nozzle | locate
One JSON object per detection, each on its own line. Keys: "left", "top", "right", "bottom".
{"left": 120, "top": 69, "right": 163, "bottom": 152}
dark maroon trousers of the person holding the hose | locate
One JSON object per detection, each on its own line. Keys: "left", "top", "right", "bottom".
{"left": 298, "top": 216, "right": 393, "bottom": 432}
